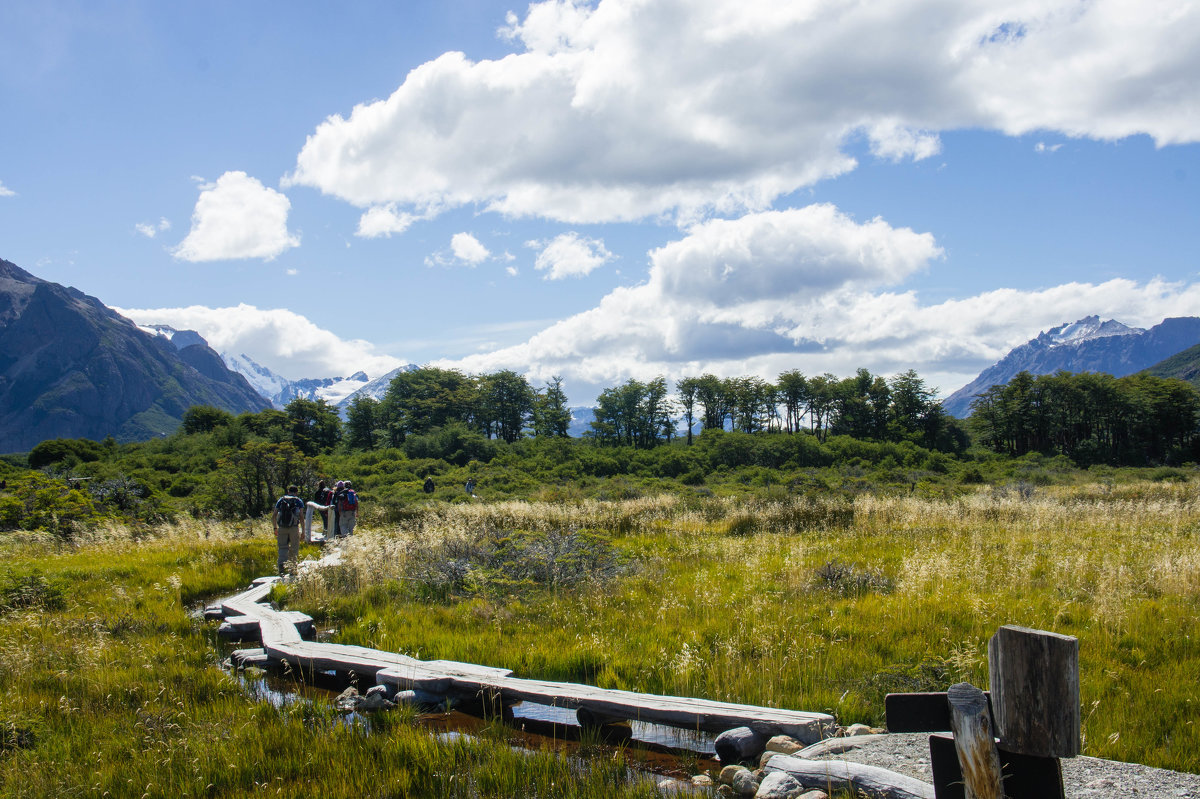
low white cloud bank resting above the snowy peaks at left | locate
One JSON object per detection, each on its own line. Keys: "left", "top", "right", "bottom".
{"left": 114, "top": 304, "right": 403, "bottom": 380}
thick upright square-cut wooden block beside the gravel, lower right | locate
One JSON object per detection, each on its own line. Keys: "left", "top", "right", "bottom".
{"left": 988, "top": 625, "right": 1081, "bottom": 757}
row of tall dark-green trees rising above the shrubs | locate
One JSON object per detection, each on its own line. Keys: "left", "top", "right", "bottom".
{"left": 164, "top": 367, "right": 1200, "bottom": 465}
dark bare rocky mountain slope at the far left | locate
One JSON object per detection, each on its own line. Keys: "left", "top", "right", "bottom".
{"left": 0, "top": 259, "right": 266, "bottom": 452}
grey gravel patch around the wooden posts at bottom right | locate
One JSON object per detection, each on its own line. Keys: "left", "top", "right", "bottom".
{"left": 797, "top": 733, "right": 1200, "bottom": 799}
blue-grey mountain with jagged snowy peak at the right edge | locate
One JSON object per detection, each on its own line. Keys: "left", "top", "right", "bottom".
{"left": 942, "top": 316, "right": 1200, "bottom": 417}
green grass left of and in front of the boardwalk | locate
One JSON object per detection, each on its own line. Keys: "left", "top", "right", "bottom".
{"left": 0, "top": 520, "right": 656, "bottom": 799}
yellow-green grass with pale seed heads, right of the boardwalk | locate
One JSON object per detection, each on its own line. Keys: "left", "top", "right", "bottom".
{"left": 289, "top": 482, "right": 1200, "bottom": 771}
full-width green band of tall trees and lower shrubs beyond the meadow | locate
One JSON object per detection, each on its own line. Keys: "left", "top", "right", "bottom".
{"left": 11, "top": 359, "right": 1200, "bottom": 523}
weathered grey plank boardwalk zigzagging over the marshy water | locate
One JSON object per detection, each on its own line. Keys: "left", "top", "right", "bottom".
{"left": 221, "top": 577, "right": 834, "bottom": 744}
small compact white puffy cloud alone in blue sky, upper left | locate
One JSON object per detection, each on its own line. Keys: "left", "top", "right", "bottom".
{"left": 172, "top": 172, "right": 300, "bottom": 262}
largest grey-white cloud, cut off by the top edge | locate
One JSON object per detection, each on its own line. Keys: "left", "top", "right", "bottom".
{"left": 284, "top": 0, "right": 1200, "bottom": 223}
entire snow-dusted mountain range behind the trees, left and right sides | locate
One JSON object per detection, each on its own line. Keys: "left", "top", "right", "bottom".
{"left": 0, "top": 259, "right": 1200, "bottom": 452}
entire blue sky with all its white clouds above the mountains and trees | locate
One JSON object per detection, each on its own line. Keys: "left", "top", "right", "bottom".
{"left": 0, "top": 0, "right": 1200, "bottom": 403}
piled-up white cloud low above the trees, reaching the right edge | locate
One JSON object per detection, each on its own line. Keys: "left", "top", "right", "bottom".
{"left": 444, "top": 205, "right": 1200, "bottom": 400}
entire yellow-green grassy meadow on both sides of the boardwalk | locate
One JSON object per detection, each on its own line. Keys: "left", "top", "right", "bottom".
{"left": 0, "top": 480, "right": 1200, "bottom": 797}
